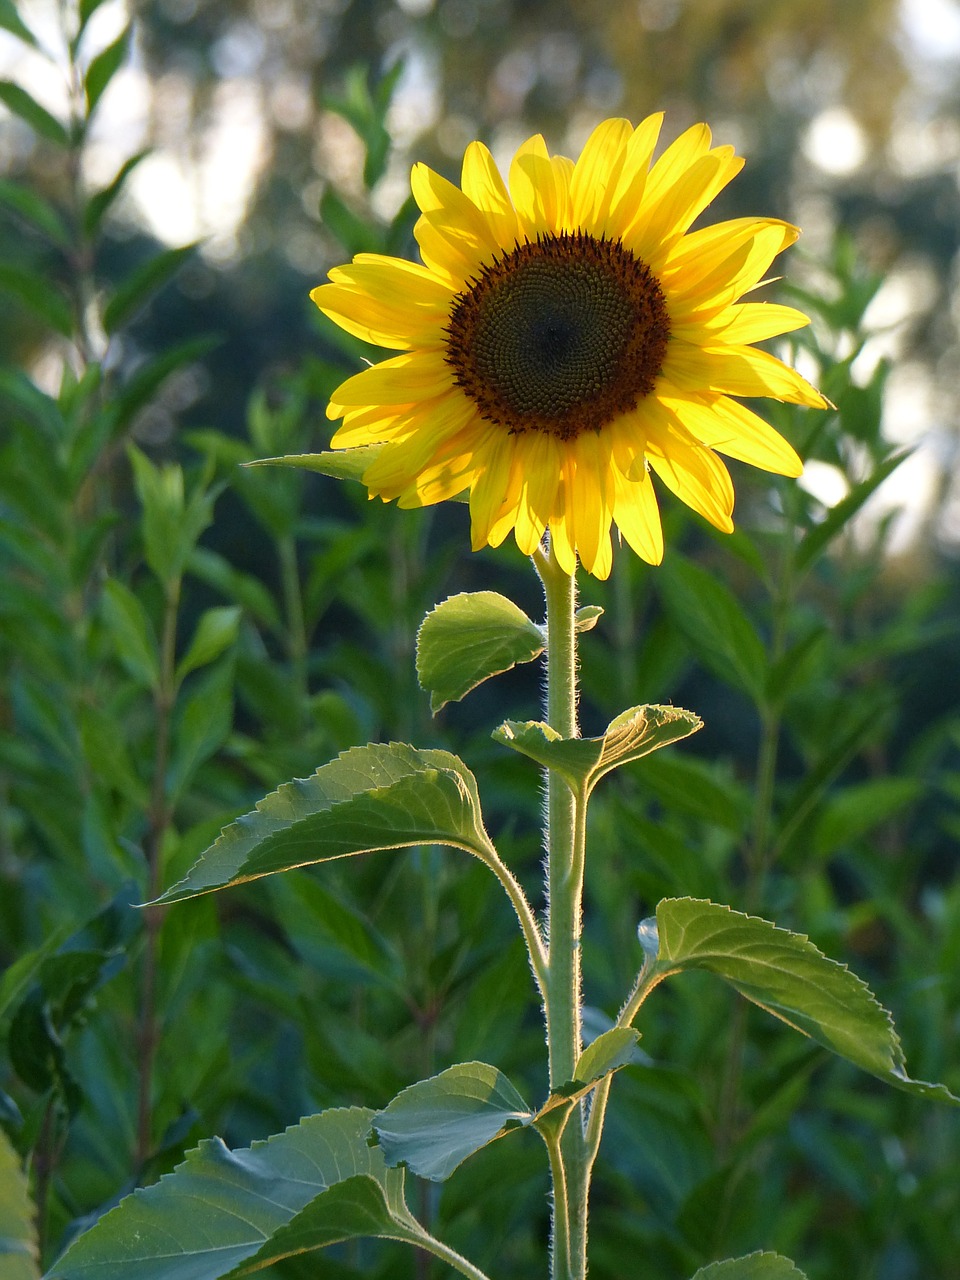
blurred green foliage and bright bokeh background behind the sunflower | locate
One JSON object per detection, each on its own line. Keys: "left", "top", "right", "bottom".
{"left": 0, "top": 0, "right": 960, "bottom": 1280}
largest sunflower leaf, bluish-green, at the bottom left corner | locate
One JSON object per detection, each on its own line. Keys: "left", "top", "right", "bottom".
{"left": 47, "top": 1107, "right": 416, "bottom": 1280}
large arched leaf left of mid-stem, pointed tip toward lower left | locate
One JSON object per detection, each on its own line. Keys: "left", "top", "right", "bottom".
{"left": 157, "top": 742, "right": 492, "bottom": 902}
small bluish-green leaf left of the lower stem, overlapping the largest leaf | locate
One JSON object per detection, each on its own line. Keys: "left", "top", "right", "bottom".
{"left": 372, "top": 1062, "right": 534, "bottom": 1181}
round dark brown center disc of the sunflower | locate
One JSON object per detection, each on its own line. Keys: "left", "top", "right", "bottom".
{"left": 447, "top": 232, "right": 669, "bottom": 440}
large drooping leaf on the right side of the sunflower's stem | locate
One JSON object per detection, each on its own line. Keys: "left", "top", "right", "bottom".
{"left": 645, "top": 897, "right": 960, "bottom": 1105}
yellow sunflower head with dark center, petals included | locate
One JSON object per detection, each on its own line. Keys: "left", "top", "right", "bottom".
{"left": 311, "top": 115, "right": 828, "bottom": 577}
